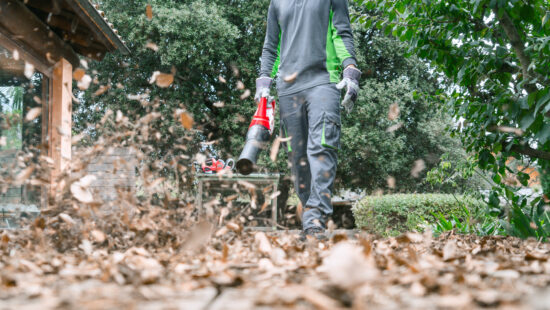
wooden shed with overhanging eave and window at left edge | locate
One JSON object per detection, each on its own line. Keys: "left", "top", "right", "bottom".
{"left": 0, "top": 0, "right": 129, "bottom": 223}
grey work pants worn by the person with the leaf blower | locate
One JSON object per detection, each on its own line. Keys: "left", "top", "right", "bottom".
{"left": 279, "top": 84, "right": 340, "bottom": 229}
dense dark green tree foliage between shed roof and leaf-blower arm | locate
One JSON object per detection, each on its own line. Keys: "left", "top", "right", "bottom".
{"left": 74, "top": 0, "right": 294, "bottom": 186}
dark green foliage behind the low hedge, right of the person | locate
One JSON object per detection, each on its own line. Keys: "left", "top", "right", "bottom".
{"left": 337, "top": 21, "right": 473, "bottom": 192}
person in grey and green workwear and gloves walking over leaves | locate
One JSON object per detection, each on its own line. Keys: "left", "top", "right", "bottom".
{"left": 255, "top": 0, "right": 361, "bottom": 238}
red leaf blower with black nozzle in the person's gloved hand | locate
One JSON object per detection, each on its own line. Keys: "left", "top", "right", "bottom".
{"left": 237, "top": 97, "right": 275, "bottom": 175}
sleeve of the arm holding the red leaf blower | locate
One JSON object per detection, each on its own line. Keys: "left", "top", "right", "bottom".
{"left": 260, "top": 0, "right": 281, "bottom": 78}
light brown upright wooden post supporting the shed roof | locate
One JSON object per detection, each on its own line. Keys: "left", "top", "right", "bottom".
{"left": 48, "top": 58, "right": 72, "bottom": 197}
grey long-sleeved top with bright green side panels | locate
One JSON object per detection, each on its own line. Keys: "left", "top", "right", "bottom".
{"left": 260, "top": 0, "right": 356, "bottom": 96}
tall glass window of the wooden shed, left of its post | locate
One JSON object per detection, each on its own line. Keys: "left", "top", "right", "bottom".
{"left": 0, "top": 45, "right": 49, "bottom": 228}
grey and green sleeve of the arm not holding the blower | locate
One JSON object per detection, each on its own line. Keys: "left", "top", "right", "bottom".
{"left": 331, "top": 0, "right": 357, "bottom": 68}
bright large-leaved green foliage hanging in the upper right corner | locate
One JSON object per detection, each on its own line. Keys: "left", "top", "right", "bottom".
{"left": 356, "top": 0, "right": 550, "bottom": 236}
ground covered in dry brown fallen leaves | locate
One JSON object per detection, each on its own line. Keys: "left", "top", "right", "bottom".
{"left": 0, "top": 217, "right": 550, "bottom": 310}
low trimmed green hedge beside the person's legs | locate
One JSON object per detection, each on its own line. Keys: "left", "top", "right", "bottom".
{"left": 353, "top": 194, "right": 485, "bottom": 236}
